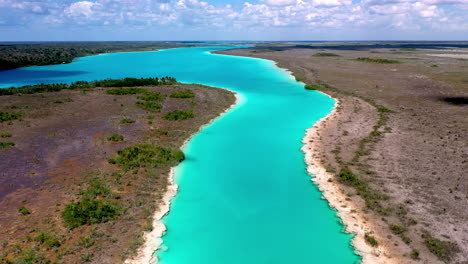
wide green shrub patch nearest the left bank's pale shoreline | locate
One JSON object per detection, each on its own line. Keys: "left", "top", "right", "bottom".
{"left": 109, "top": 145, "right": 185, "bottom": 170}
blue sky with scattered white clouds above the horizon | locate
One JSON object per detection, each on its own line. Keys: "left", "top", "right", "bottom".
{"left": 0, "top": 0, "right": 468, "bottom": 41}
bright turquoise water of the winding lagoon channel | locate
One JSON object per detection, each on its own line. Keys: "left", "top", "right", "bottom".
{"left": 0, "top": 47, "right": 360, "bottom": 264}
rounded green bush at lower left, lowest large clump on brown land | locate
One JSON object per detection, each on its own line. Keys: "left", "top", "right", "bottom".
{"left": 62, "top": 199, "right": 120, "bottom": 228}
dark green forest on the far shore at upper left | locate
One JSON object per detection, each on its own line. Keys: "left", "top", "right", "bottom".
{"left": 0, "top": 42, "right": 181, "bottom": 70}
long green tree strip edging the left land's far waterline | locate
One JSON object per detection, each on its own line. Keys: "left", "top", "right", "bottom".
{"left": 0, "top": 77, "right": 177, "bottom": 96}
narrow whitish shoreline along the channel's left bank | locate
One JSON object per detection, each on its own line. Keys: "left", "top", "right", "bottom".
{"left": 124, "top": 91, "right": 241, "bottom": 264}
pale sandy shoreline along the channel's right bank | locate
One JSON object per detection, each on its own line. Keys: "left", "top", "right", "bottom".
{"left": 301, "top": 95, "right": 400, "bottom": 264}
